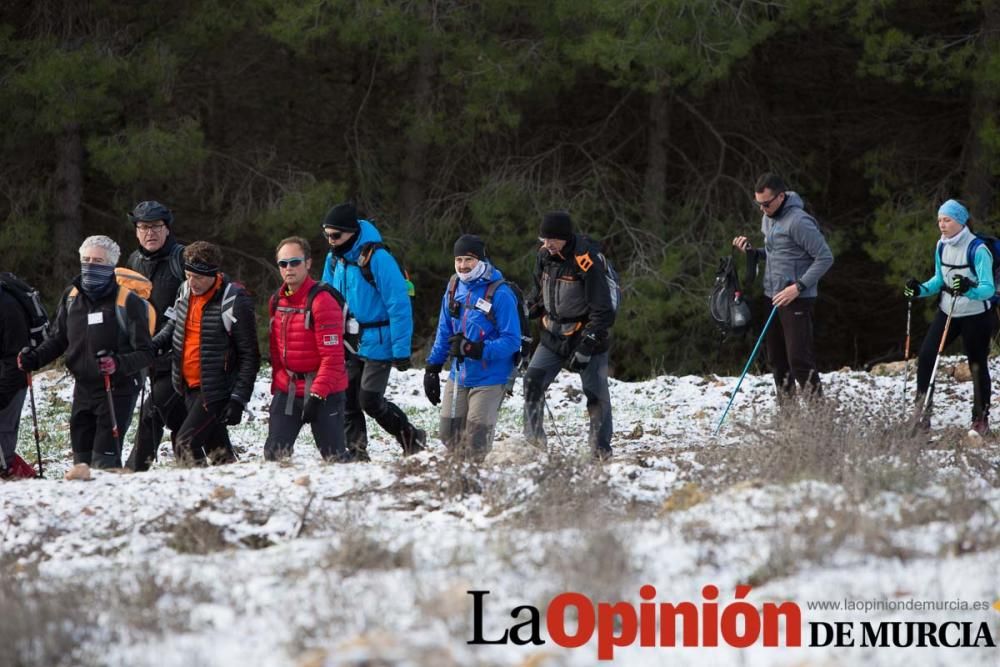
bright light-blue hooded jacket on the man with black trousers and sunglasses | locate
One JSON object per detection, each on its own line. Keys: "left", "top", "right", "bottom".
{"left": 323, "top": 220, "right": 413, "bottom": 361}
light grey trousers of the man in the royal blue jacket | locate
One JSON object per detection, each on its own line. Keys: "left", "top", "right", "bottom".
{"left": 439, "top": 378, "right": 504, "bottom": 459}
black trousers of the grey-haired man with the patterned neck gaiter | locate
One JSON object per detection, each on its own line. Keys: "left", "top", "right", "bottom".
{"left": 69, "top": 376, "right": 139, "bottom": 468}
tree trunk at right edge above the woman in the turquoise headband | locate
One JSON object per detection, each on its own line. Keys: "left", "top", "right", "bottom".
{"left": 962, "top": 1, "right": 1000, "bottom": 220}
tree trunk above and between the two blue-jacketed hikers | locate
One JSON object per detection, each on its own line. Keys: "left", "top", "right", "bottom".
{"left": 399, "top": 30, "right": 434, "bottom": 230}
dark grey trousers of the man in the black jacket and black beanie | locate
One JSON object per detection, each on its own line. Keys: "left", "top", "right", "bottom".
{"left": 524, "top": 345, "right": 613, "bottom": 454}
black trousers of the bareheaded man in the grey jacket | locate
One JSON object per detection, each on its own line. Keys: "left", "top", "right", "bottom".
{"left": 764, "top": 299, "right": 822, "bottom": 396}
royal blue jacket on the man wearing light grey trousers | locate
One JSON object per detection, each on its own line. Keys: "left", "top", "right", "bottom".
{"left": 427, "top": 266, "right": 521, "bottom": 387}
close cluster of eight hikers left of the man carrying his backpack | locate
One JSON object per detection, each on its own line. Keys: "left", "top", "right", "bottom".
{"left": 0, "top": 201, "right": 620, "bottom": 478}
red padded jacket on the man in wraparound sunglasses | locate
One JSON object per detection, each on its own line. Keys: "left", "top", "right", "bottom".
{"left": 270, "top": 277, "right": 347, "bottom": 398}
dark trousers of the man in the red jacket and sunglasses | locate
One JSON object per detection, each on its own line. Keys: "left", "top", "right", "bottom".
{"left": 264, "top": 391, "right": 349, "bottom": 461}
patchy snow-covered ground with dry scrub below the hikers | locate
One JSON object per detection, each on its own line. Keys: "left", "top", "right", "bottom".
{"left": 0, "top": 366, "right": 1000, "bottom": 667}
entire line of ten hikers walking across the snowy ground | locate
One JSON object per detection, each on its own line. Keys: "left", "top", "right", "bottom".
{"left": 0, "top": 168, "right": 1000, "bottom": 477}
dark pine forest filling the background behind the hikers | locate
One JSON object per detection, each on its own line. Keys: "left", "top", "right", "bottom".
{"left": 0, "top": 0, "right": 1000, "bottom": 378}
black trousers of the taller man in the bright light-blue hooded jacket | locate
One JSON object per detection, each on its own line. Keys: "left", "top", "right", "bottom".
{"left": 344, "top": 355, "right": 422, "bottom": 461}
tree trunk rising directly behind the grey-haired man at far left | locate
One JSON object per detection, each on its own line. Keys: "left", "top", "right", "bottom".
{"left": 52, "top": 123, "right": 83, "bottom": 283}
